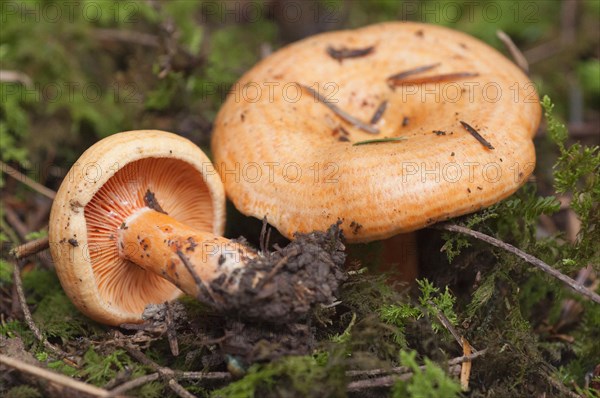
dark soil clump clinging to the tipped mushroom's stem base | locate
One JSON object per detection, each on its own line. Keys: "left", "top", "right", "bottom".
{"left": 209, "top": 224, "right": 346, "bottom": 324}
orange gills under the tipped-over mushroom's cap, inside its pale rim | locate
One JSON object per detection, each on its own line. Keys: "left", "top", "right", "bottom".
{"left": 85, "top": 158, "right": 213, "bottom": 313}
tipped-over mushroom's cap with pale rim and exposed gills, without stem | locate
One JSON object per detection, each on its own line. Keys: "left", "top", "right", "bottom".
{"left": 49, "top": 130, "right": 225, "bottom": 325}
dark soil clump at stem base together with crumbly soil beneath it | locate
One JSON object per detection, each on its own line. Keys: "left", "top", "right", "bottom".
{"left": 210, "top": 223, "right": 346, "bottom": 364}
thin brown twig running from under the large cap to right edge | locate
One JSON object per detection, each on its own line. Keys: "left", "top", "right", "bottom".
{"left": 433, "top": 224, "right": 600, "bottom": 304}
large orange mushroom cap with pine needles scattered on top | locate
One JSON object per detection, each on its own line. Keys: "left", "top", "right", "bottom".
{"left": 212, "top": 22, "right": 540, "bottom": 242}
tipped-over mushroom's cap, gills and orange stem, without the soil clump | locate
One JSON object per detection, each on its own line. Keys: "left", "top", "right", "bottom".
{"left": 49, "top": 131, "right": 245, "bottom": 325}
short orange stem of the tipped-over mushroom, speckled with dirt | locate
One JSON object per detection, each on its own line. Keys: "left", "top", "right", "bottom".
{"left": 118, "top": 207, "right": 255, "bottom": 297}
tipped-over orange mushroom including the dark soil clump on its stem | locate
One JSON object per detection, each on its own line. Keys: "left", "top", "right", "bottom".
{"left": 49, "top": 131, "right": 343, "bottom": 325}
